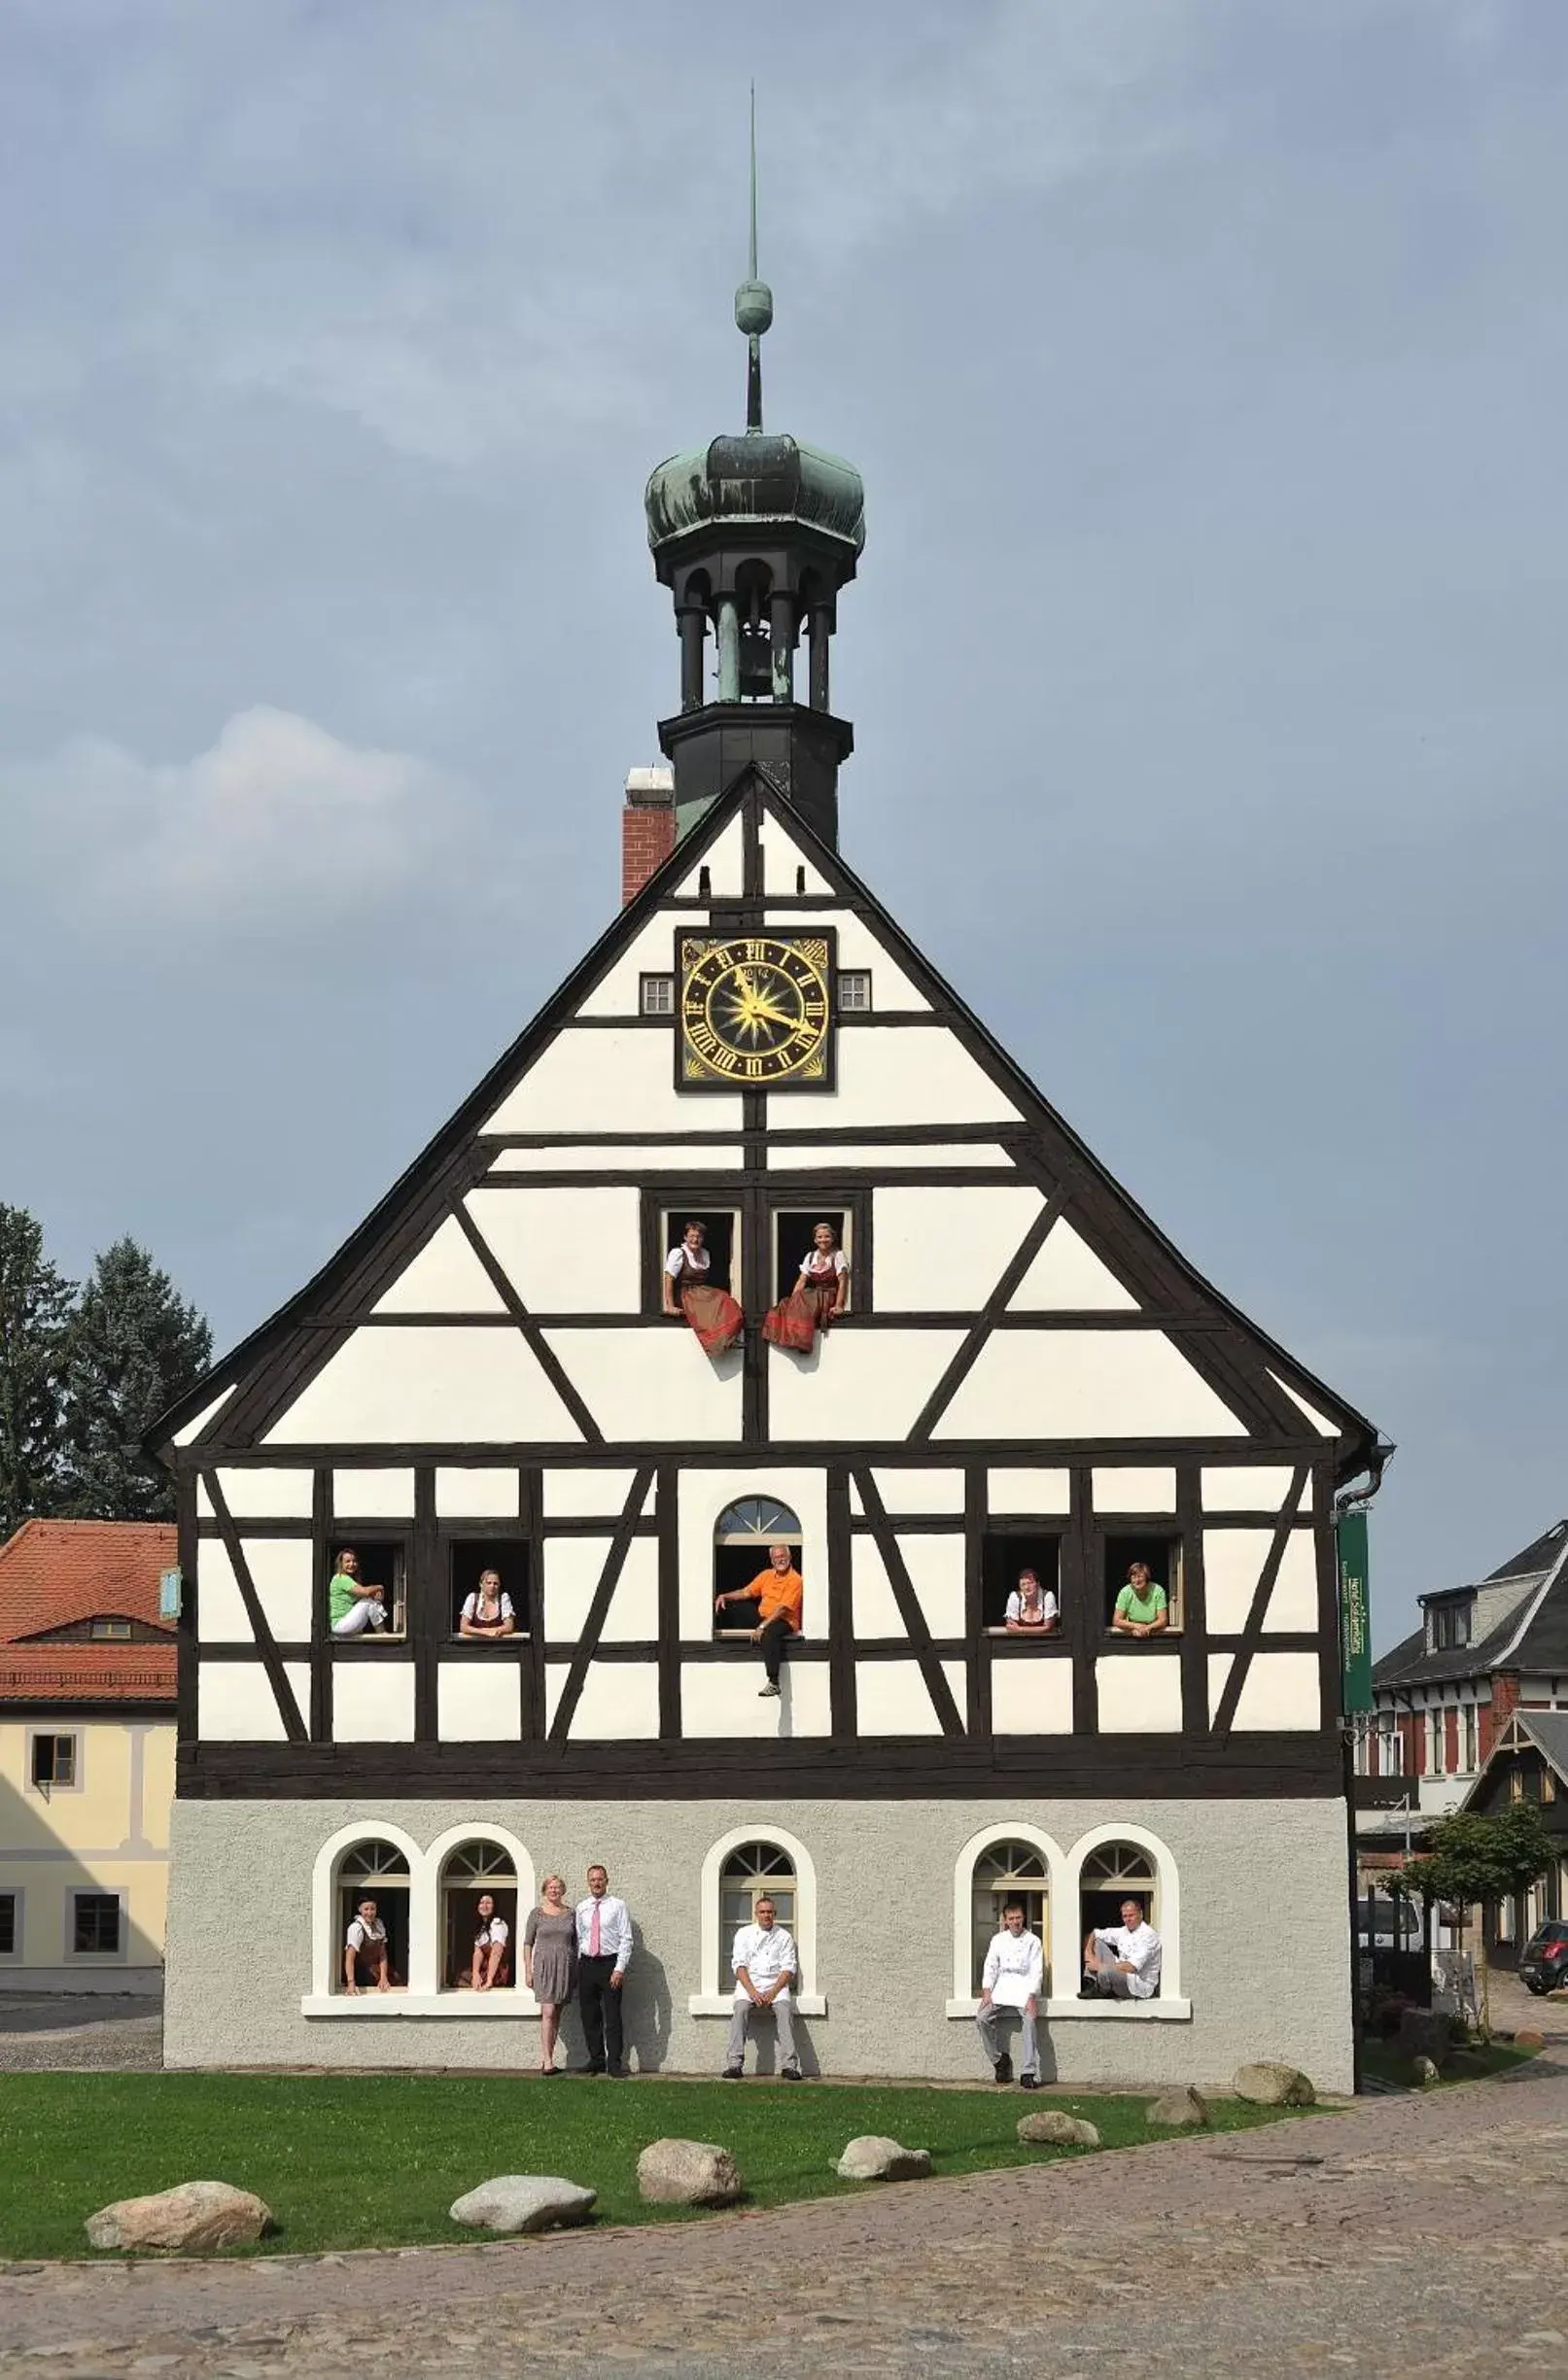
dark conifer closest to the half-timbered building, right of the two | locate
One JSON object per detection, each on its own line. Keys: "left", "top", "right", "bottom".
{"left": 57, "top": 1235, "right": 212, "bottom": 1521}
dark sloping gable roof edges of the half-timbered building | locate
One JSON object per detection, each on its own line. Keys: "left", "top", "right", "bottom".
{"left": 148, "top": 764, "right": 1377, "bottom": 1478}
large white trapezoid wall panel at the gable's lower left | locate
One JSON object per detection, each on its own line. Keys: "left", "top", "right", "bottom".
{"left": 266, "top": 1324, "right": 580, "bottom": 1447}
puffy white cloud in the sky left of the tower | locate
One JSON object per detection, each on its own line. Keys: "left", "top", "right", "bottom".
{"left": 0, "top": 705, "right": 467, "bottom": 928}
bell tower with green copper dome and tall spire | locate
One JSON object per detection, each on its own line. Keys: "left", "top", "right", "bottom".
{"left": 645, "top": 95, "right": 866, "bottom": 845}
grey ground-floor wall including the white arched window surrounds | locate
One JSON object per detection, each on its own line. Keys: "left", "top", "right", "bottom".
{"left": 164, "top": 1797, "right": 1351, "bottom": 2089}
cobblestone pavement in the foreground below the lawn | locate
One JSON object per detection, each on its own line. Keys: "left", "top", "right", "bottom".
{"left": 0, "top": 2052, "right": 1568, "bottom": 2380}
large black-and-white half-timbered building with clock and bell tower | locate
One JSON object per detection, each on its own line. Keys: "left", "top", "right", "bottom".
{"left": 155, "top": 224, "right": 1377, "bottom": 2089}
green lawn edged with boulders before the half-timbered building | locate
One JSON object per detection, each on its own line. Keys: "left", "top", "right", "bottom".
{"left": 0, "top": 2073, "right": 1282, "bottom": 2257}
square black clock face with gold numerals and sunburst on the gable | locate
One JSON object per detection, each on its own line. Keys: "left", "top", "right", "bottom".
{"left": 680, "top": 935, "right": 828, "bottom": 1087}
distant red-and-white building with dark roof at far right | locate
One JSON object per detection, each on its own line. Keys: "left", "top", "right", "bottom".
{"left": 1356, "top": 1521, "right": 1568, "bottom": 1833}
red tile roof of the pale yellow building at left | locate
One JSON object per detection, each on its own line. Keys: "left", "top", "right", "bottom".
{"left": 0, "top": 1521, "right": 176, "bottom": 1702}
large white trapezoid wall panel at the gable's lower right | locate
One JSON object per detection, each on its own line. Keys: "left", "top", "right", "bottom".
{"left": 923, "top": 1330, "right": 1247, "bottom": 1437}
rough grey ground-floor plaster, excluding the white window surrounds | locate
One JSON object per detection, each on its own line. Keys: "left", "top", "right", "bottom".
{"left": 164, "top": 1799, "right": 1351, "bottom": 2089}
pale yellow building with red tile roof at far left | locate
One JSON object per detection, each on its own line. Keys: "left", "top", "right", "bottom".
{"left": 0, "top": 1521, "right": 176, "bottom": 1992}
